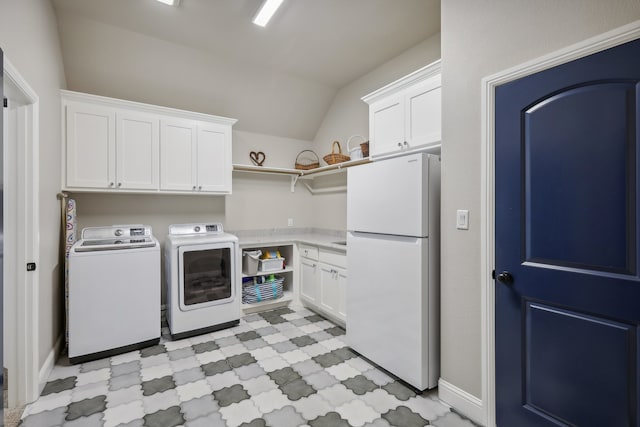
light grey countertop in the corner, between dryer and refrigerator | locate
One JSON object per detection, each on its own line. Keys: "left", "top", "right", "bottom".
{"left": 230, "top": 228, "right": 347, "bottom": 252}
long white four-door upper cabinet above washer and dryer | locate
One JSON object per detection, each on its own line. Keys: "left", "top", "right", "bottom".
{"left": 62, "top": 91, "right": 236, "bottom": 194}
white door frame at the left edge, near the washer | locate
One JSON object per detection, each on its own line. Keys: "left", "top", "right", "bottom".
{"left": 3, "top": 55, "right": 40, "bottom": 407}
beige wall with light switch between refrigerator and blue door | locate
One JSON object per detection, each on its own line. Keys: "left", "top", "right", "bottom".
{"left": 441, "top": 0, "right": 640, "bottom": 408}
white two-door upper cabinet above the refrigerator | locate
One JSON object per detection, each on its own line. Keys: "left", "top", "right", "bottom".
{"left": 362, "top": 61, "right": 442, "bottom": 158}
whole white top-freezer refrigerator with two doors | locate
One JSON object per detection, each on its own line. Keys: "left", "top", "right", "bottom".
{"left": 346, "top": 153, "right": 440, "bottom": 390}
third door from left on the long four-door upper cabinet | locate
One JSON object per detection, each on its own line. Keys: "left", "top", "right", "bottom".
{"left": 160, "top": 120, "right": 196, "bottom": 191}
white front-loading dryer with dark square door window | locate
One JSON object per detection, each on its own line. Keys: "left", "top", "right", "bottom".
{"left": 164, "top": 224, "right": 241, "bottom": 339}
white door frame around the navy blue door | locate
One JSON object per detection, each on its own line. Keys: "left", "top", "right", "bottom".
{"left": 480, "top": 20, "right": 640, "bottom": 427}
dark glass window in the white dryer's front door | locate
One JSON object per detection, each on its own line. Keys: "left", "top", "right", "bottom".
{"left": 180, "top": 244, "right": 235, "bottom": 310}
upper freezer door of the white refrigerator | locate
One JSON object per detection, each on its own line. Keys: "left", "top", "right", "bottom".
{"left": 347, "top": 153, "right": 432, "bottom": 237}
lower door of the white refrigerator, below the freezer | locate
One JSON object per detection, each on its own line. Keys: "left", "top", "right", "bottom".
{"left": 346, "top": 232, "right": 439, "bottom": 390}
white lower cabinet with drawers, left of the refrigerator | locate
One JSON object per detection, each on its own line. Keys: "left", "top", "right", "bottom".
{"left": 299, "top": 245, "right": 347, "bottom": 323}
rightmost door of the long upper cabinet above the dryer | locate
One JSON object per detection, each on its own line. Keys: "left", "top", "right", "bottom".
{"left": 196, "top": 124, "right": 231, "bottom": 193}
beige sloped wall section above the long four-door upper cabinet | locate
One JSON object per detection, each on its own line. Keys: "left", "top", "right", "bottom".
{"left": 58, "top": 11, "right": 336, "bottom": 139}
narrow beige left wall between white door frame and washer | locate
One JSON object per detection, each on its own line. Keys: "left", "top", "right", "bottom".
{"left": 0, "top": 0, "right": 65, "bottom": 366}
